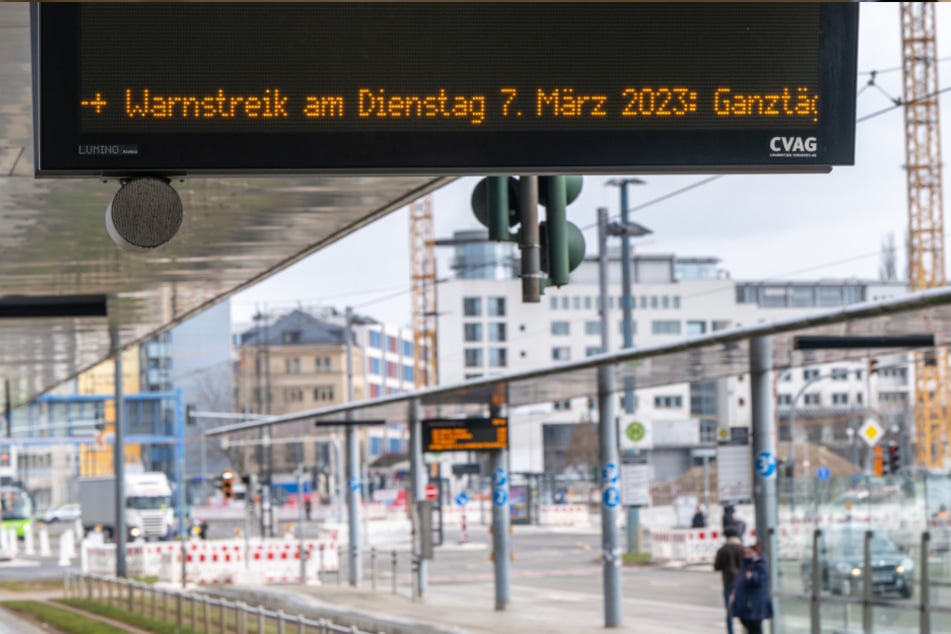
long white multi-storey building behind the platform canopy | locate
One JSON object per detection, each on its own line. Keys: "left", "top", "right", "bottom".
{"left": 437, "top": 230, "right": 913, "bottom": 481}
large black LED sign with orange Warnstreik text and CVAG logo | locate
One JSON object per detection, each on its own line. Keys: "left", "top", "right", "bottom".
{"left": 33, "top": 2, "right": 858, "bottom": 176}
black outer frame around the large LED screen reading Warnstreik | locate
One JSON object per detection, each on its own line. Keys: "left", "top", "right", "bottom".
{"left": 32, "top": 2, "right": 858, "bottom": 177}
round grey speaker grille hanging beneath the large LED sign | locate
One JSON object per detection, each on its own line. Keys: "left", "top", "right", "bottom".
{"left": 106, "top": 178, "right": 184, "bottom": 251}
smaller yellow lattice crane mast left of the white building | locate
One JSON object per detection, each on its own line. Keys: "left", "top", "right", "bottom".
{"left": 409, "top": 194, "right": 438, "bottom": 388}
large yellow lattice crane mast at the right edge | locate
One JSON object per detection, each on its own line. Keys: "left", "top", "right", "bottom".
{"left": 901, "top": 2, "right": 951, "bottom": 470}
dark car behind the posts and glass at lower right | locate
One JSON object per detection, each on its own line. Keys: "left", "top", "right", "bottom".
{"left": 801, "top": 526, "right": 915, "bottom": 599}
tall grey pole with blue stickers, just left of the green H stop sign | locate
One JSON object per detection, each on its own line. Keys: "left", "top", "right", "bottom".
{"left": 598, "top": 207, "right": 623, "bottom": 627}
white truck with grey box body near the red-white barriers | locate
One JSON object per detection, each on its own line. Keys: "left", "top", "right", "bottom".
{"left": 79, "top": 471, "right": 175, "bottom": 541}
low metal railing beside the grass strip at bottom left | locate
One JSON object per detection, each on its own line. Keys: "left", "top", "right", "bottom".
{"left": 64, "top": 572, "right": 381, "bottom": 634}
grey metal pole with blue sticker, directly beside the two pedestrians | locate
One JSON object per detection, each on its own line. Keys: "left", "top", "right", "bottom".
{"left": 750, "top": 336, "right": 782, "bottom": 623}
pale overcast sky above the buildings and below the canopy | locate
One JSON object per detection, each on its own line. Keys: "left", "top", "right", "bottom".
{"left": 232, "top": 3, "right": 951, "bottom": 325}
